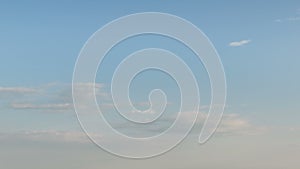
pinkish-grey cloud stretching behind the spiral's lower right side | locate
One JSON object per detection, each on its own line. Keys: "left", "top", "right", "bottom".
{"left": 108, "top": 108, "right": 267, "bottom": 136}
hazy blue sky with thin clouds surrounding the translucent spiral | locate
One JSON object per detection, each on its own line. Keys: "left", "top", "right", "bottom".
{"left": 0, "top": 0, "right": 300, "bottom": 169}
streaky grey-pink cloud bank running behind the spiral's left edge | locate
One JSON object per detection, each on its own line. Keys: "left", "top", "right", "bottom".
{"left": 0, "top": 83, "right": 108, "bottom": 112}
